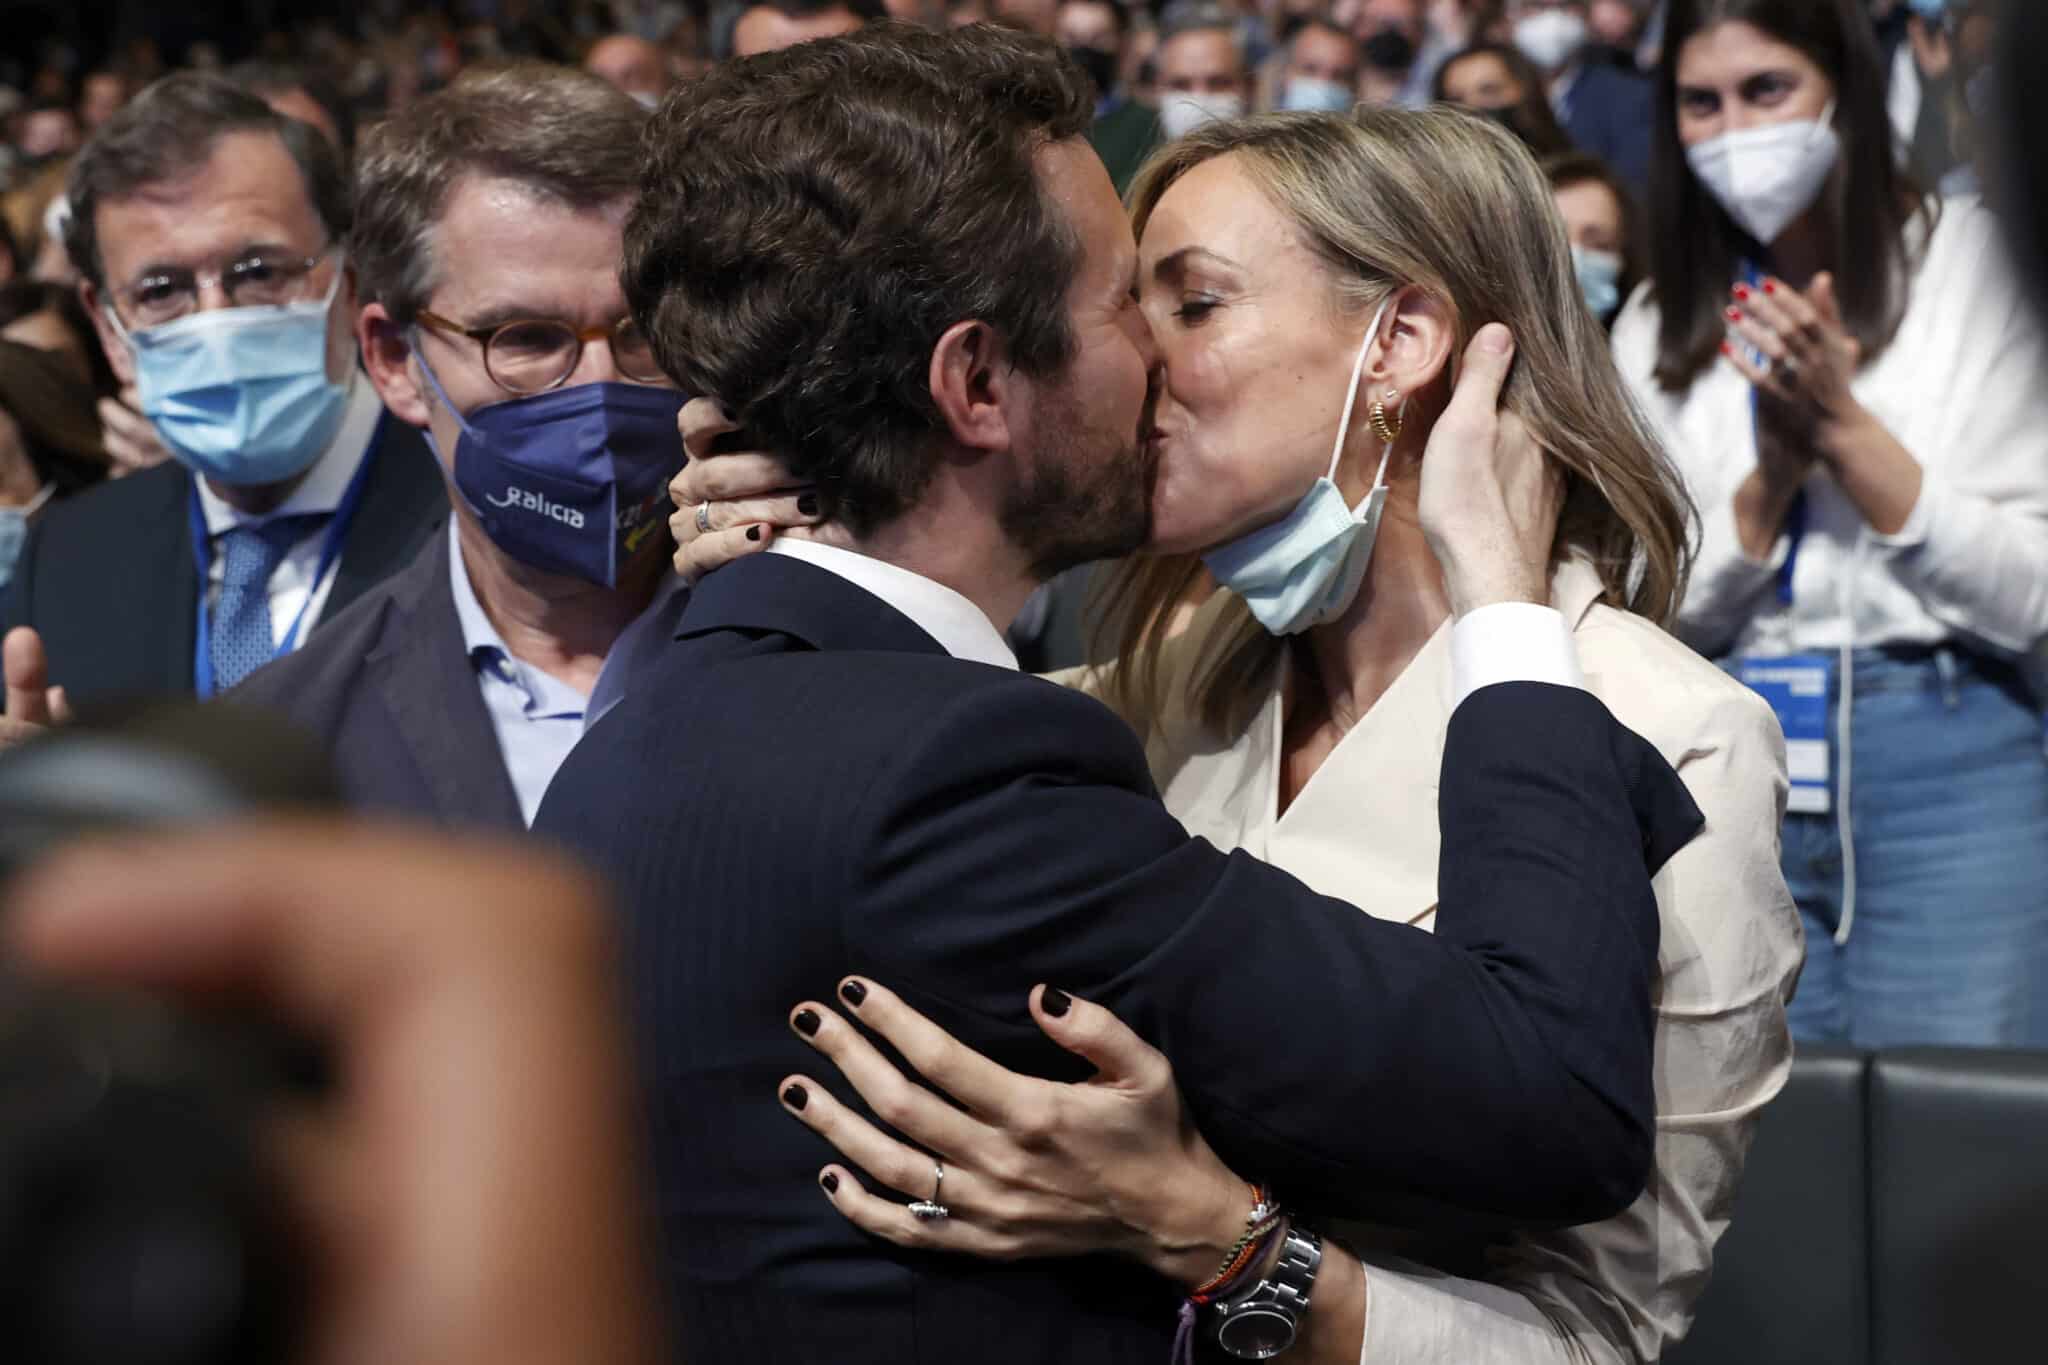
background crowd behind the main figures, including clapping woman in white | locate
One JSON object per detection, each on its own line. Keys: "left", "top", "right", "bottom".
{"left": 0, "top": 0, "right": 2048, "bottom": 1042}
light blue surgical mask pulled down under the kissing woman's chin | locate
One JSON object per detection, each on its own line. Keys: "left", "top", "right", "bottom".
{"left": 1202, "top": 299, "right": 1395, "bottom": 634}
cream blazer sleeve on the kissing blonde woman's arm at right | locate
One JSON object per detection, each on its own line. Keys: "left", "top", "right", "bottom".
{"left": 1360, "top": 695, "right": 1802, "bottom": 1365}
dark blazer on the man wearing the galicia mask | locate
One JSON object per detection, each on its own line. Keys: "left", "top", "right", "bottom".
{"left": 227, "top": 528, "right": 526, "bottom": 831}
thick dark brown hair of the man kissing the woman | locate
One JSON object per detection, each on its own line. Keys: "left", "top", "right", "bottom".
{"left": 623, "top": 25, "right": 1094, "bottom": 534}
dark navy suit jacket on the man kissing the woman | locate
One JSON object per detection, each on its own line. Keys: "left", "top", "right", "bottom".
{"left": 535, "top": 555, "right": 1700, "bottom": 1365}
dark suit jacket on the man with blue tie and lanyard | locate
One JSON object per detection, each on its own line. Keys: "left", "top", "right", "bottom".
{"left": 0, "top": 415, "right": 449, "bottom": 704}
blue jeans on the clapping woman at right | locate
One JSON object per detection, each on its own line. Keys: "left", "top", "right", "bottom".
{"left": 1784, "top": 649, "right": 2048, "bottom": 1048}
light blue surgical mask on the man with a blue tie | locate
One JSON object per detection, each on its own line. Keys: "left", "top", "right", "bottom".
{"left": 113, "top": 261, "right": 348, "bottom": 487}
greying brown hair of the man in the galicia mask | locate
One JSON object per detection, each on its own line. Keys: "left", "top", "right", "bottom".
{"left": 348, "top": 61, "right": 647, "bottom": 325}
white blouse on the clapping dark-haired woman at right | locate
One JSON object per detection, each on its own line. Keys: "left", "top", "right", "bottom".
{"left": 1614, "top": 196, "right": 2048, "bottom": 655}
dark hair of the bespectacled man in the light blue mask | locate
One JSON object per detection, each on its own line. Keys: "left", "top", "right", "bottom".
{"left": 63, "top": 72, "right": 350, "bottom": 289}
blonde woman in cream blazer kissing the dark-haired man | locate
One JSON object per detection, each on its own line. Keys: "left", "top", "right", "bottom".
{"left": 676, "top": 111, "right": 1800, "bottom": 1365}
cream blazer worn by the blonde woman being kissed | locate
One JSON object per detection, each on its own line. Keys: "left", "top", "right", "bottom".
{"left": 1069, "top": 561, "right": 1802, "bottom": 1365}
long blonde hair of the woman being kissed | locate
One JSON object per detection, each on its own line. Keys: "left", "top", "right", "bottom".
{"left": 1094, "top": 106, "right": 1692, "bottom": 735}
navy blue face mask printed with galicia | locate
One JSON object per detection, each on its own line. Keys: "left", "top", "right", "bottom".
{"left": 414, "top": 350, "right": 684, "bottom": 587}
